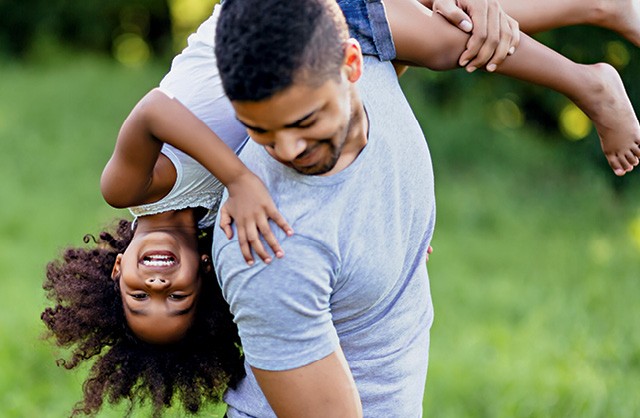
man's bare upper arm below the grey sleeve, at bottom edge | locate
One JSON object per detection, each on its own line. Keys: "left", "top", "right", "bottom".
{"left": 251, "top": 349, "right": 362, "bottom": 418}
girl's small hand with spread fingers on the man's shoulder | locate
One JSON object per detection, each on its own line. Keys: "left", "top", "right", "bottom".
{"left": 218, "top": 172, "right": 293, "bottom": 265}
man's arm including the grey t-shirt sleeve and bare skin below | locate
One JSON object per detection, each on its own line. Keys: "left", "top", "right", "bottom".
{"left": 213, "top": 233, "right": 362, "bottom": 418}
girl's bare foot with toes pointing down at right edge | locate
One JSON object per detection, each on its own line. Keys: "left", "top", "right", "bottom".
{"left": 575, "top": 62, "right": 640, "bottom": 176}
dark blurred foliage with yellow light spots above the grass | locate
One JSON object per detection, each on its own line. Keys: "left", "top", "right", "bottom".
{"left": 0, "top": 0, "right": 640, "bottom": 188}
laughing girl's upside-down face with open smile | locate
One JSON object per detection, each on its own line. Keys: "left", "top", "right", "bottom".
{"left": 112, "top": 229, "right": 205, "bottom": 344}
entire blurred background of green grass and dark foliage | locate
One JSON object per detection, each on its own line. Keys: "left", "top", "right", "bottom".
{"left": 0, "top": 0, "right": 640, "bottom": 418}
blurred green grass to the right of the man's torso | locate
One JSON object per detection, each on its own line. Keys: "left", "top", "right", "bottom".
{"left": 406, "top": 70, "right": 640, "bottom": 418}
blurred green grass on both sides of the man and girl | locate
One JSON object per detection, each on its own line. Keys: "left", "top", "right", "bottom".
{"left": 0, "top": 56, "right": 640, "bottom": 418}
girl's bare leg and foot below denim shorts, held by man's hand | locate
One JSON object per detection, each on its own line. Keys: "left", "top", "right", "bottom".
{"left": 386, "top": 0, "right": 640, "bottom": 175}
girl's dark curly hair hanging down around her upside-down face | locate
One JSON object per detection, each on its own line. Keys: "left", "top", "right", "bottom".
{"left": 41, "top": 220, "right": 244, "bottom": 416}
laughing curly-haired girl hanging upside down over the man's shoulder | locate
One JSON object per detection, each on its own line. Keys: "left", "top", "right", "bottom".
{"left": 43, "top": 0, "right": 640, "bottom": 413}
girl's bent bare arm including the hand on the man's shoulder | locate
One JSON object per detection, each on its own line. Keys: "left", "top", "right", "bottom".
{"left": 100, "top": 89, "right": 293, "bottom": 262}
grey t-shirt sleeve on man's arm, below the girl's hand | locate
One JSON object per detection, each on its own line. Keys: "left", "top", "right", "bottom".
{"left": 214, "top": 235, "right": 339, "bottom": 371}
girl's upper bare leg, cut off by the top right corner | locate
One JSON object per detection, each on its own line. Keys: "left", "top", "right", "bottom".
{"left": 500, "top": 0, "right": 640, "bottom": 47}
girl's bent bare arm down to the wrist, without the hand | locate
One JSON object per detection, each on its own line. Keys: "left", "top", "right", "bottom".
{"left": 100, "top": 89, "right": 251, "bottom": 208}
